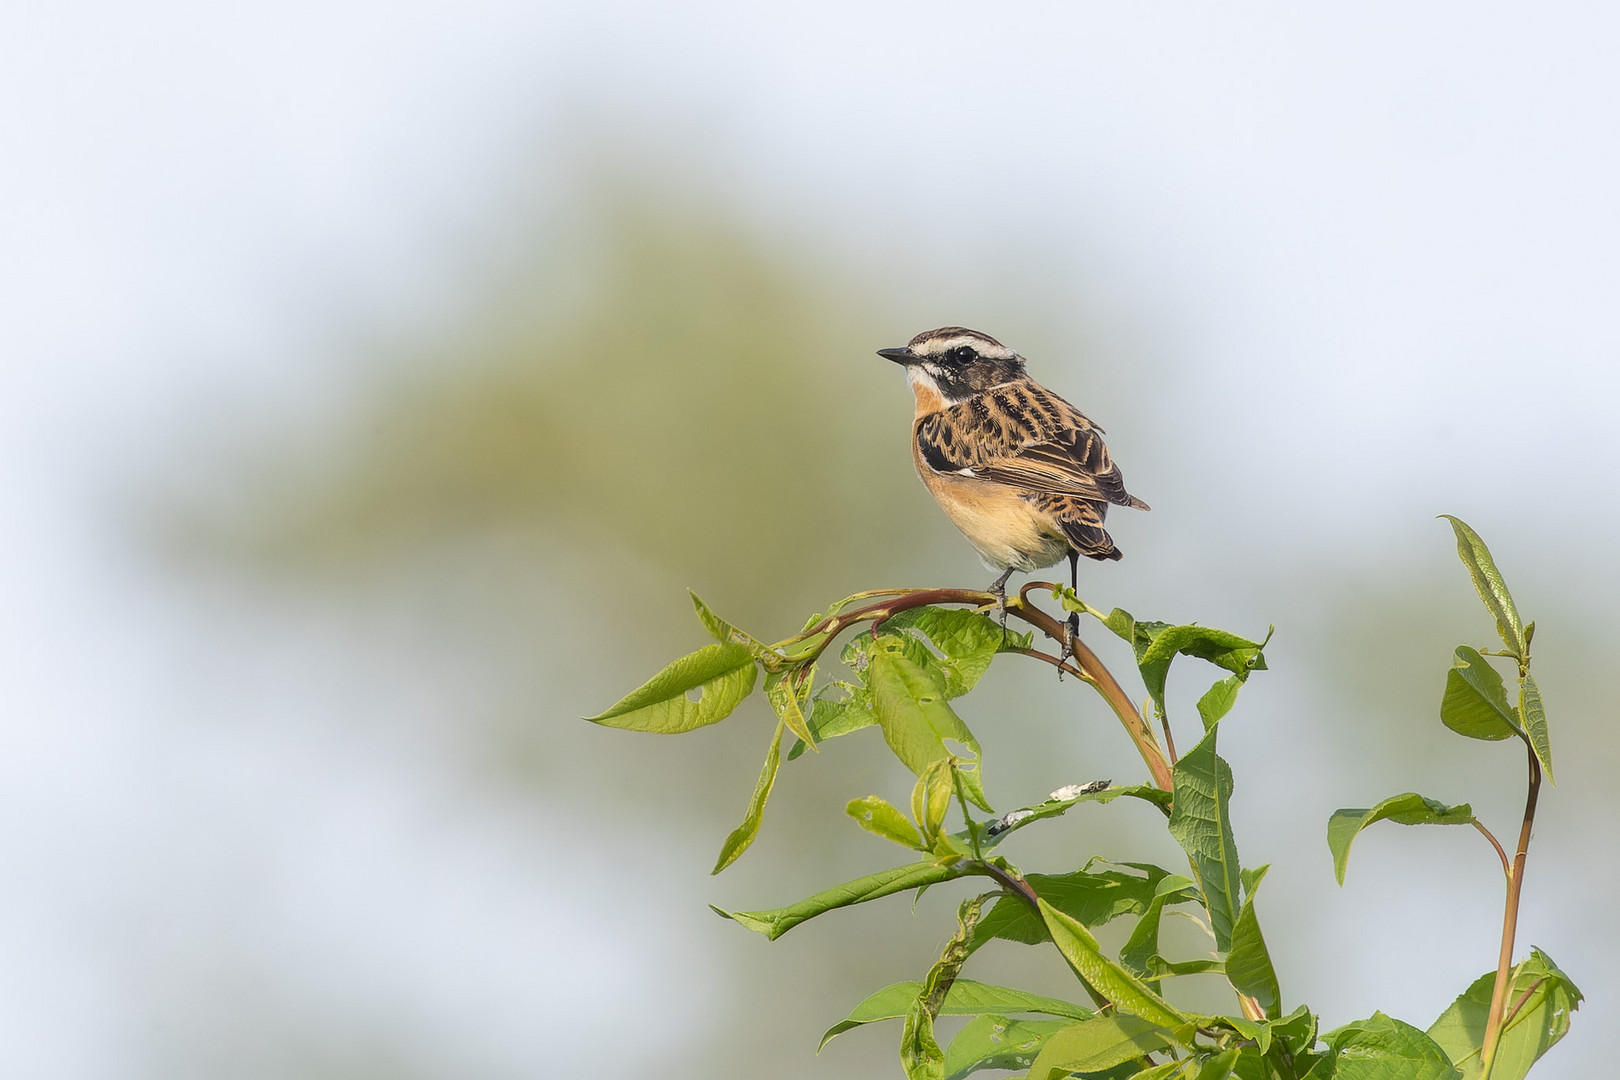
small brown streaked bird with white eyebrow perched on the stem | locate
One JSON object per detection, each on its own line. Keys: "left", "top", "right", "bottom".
{"left": 878, "top": 325, "right": 1149, "bottom": 653}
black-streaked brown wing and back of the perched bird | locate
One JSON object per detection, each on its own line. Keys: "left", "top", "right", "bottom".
{"left": 917, "top": 382, "right": 1147, "bottom": 510}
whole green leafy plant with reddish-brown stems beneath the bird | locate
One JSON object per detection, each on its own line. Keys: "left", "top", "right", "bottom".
{"left": 588, "top": 518, "right": 1581, "bottom": 1080}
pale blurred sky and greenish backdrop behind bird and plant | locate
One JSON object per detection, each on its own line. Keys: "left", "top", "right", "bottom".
{"left": 0, "top": 0, "right": 1620, "bottom": 1080}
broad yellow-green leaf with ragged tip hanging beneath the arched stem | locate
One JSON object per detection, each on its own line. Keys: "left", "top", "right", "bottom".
{"left": 867, "top": 638, "right": 990, "bottom": 810}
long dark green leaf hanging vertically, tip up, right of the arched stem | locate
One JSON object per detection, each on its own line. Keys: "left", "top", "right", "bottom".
{"left": 1170, "top": 727, "right": 1239, "bottom": 952}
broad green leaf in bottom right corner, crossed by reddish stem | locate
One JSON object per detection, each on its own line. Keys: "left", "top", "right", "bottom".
{"left": 1429, "top": 949, "right": 1583, "bottom": 1080}
